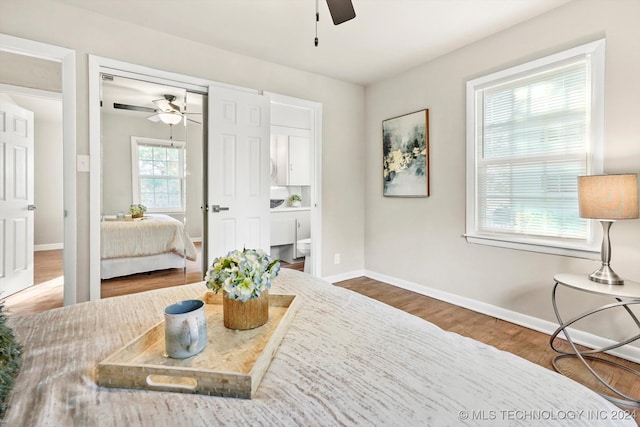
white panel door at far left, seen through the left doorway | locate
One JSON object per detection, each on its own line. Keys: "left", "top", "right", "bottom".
{"left": 0, "top": 103, "right": 34, "bottom": 298}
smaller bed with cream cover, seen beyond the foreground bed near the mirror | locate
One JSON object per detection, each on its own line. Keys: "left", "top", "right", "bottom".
{"left": 100, "top": 214, "right": 197, "bottom": 279}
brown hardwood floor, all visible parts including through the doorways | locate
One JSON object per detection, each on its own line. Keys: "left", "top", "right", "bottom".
{"left": 5, "top": 252, "right": 640, "bottom": 416}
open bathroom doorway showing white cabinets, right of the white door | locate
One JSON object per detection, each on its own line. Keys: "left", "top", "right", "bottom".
{"left": 265, "top": 93, "right": 322, "bottom": 276}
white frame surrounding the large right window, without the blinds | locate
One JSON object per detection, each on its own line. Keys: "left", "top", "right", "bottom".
{"left": 464, "top": 39, "right": 606, "bottom": 259}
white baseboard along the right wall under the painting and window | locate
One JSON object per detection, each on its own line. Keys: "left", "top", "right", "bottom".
{"left": 362, "top": 270, "right": 640, "bottom": 363}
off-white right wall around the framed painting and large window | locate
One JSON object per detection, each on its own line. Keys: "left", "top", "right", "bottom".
{"left": 364, "top": 0, "right": 640, "bottom": 348}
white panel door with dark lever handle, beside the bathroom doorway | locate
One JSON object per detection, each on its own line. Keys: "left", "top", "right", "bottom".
{"left": 207, "top": 86, "right": 270, "bottom": 264}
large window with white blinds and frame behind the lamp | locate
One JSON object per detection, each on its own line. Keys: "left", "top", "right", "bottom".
{"left": 466, "top": 40, "right": 605, "bottom": 257}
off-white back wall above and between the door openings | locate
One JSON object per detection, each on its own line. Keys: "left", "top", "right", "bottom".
{"left": 0, "top": 0, "right": 364, "bottom": 301}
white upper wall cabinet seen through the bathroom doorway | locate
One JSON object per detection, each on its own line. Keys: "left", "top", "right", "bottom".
{"left": 271, "top": 126, "right": 311, "bottom": 186}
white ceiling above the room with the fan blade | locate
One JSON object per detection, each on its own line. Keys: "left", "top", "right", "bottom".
{"left": 55, "top": 0, "right": 570, "bottom": 85}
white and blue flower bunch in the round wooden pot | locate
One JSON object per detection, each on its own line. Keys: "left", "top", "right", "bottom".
{"left": 204, "top": 249, "right": 280, "bottom": 302}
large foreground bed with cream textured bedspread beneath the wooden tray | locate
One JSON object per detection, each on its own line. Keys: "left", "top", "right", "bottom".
{"left": 4, "top": 269, "right": 636, "bottom": 426}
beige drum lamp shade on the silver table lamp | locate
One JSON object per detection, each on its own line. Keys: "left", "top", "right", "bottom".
{"left": 578, "top": 174, "right": 638, "bottom": 220}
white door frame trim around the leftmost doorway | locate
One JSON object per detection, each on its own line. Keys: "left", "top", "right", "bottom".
{"left": 0, "top": 34, "right": 77, "bottom": 305}
